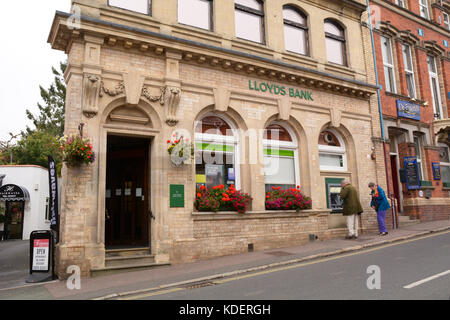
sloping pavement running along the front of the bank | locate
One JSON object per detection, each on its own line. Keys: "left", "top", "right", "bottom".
{"left": 0, "top": 220, "right": 450, "bottom": 300}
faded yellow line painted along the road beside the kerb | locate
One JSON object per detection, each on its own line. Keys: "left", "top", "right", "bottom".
{"left": 120, "top": 231, "right": 450, "bottom": 300}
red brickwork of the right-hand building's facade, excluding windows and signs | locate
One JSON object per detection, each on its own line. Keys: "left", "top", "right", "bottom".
{"left": 371, "top": 0, "right": 450, "bottom": 224}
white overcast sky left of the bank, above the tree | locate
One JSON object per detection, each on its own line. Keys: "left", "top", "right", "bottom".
{"left": 0, "top": 0, "right": 70, "bottom": 140}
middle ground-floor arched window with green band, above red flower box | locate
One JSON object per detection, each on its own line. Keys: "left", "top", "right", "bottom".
{"left": 263, "top": 122, "right": 300, "bottom": 192}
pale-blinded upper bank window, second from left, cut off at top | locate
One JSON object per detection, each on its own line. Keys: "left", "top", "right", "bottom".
{"left": 178, "top": 0, "right": 213, "bottom": 30}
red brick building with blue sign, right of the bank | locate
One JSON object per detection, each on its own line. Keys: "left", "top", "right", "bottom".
{"left": 371, "top": 0, "right": 450, "bottom": 220}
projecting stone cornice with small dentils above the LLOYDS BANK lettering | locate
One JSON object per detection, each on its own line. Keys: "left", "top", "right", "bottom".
{"left": 48, "top": 12, "right": 376, "bottom": 99}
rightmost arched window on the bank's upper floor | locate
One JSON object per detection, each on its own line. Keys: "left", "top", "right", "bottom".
{"left": 325, "top": 20, "right": 347, "bottom": 65}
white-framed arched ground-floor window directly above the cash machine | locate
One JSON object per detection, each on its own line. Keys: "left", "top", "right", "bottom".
{"left": 319, "top": 129, "right": 347, "bottom": 171}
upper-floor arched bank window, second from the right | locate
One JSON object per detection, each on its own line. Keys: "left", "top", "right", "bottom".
{"left": 283, "top": 6, "right": 309, "bottom": 55}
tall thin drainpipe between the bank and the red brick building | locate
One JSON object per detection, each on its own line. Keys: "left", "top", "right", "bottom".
{"left": 366, "top": 0, "right": 398, "bottom": 229}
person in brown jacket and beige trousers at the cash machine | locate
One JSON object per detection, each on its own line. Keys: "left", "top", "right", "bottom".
{"left": 340, "top": 180, "right": 363, "bottom": 239}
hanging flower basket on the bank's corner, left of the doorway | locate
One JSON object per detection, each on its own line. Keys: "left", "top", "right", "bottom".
{"left": 60, "top": 134, "right": 95, "bottom": 167}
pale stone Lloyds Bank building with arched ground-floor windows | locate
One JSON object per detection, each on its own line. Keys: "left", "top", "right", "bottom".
{"left": 49, "top": 0, "right": 386, "bottom": 276}
